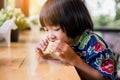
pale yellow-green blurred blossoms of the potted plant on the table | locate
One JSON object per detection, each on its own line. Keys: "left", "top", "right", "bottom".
{"left": 0, "top": 8, "right": 29, "bottom": 30}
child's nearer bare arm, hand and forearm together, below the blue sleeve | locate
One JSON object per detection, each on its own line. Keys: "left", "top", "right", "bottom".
{"left": 56, "top": 42, "right": 107, "bottom": 80}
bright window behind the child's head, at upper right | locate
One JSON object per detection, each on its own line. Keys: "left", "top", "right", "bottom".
{"left": 85, "top": 0, "right": 120, "bottom": 29}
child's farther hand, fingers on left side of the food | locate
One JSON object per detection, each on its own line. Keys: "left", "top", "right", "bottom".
{"left": 36, "top": 39, "right": 48, "bottom": 56}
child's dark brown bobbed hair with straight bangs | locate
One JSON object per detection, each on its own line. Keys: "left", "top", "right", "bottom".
{"left": 40, "top": 0, "right": 93, "bottom": 38}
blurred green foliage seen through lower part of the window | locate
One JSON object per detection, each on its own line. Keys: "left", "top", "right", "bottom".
{"left": 92, "top": 15, "right": 120, "bottom": 29}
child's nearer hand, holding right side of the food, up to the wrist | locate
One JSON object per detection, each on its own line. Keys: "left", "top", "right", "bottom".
{"left": 55, "top": 41, "right": 78, "bottom": 65}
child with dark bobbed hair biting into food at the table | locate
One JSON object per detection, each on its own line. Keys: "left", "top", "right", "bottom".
{"left": 36, "top": 0, "right": 116, "bottom": 80}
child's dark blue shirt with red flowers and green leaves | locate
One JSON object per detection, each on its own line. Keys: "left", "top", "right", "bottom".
{"left": 72, "top": 30, "right": 117, "bottom": 80}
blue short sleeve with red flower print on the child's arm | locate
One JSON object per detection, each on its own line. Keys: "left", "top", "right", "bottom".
{"left": 86, "top": 35, "right": 116, "bottom": 80}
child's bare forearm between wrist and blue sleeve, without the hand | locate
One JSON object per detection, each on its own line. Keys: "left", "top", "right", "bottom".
{"left": 72, "top": 56, "right": 108, "bottom": 80}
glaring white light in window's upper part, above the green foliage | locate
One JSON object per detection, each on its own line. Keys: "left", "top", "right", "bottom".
{"left": 86, "top": 0, "right": 115, "bottom": 16}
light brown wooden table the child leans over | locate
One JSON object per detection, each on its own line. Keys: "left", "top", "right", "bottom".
{"left": 0, "top": 31, "right": 80, "bottom": 80}
